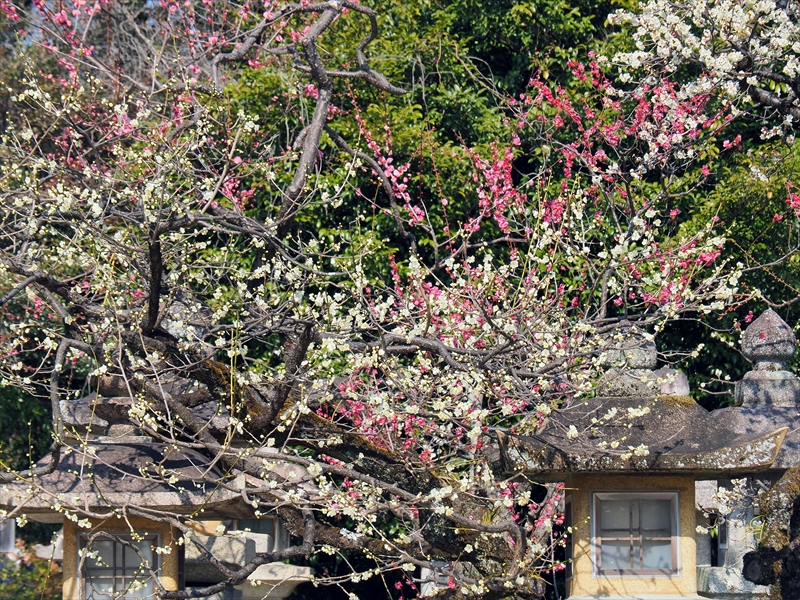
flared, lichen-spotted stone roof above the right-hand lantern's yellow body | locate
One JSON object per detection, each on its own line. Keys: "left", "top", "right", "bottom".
{"left": 499, "top": 396, "right": 787, "bottom": 480}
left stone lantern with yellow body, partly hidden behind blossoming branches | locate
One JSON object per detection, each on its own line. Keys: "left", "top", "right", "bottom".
{"left": 0, "top": 382, "right": 311, "bottom": 600}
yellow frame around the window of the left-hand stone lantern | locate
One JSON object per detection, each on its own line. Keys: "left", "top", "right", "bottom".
{"left": 63, "top": 517, "right": 180, "bottom": 600}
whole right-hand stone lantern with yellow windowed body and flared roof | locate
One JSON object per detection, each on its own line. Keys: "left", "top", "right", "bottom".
{"left": 500, "top": 323, "right": 788, "bottom": 600}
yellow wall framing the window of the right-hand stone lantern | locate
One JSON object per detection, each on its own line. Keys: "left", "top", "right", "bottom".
{"left": 566, "top": 474, "right": 697, "bottom": 598}
